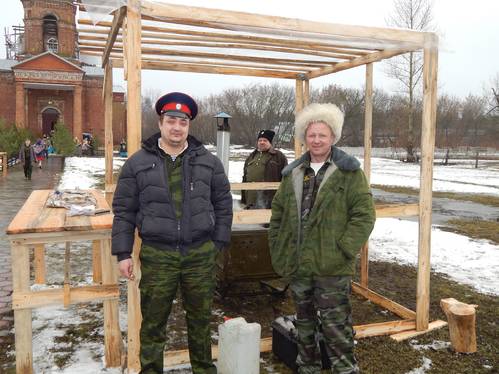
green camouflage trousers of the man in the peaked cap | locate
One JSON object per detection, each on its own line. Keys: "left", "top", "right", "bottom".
{"left": 140, "top": 242, "right": 217, "bottom": 374}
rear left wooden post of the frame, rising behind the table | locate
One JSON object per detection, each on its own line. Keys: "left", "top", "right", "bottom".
{"left": 104, "top": 61, "right": 113, "bottom": 206}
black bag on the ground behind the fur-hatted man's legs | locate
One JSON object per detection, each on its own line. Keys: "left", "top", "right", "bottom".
{"left": 271, "top": 316, "right": 331, "bottom": 373}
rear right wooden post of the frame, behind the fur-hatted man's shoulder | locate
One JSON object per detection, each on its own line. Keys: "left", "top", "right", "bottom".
{"left": 360, "top": 63, "right": 373, "bottom": 288}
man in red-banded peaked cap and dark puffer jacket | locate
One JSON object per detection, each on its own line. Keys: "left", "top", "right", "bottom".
{"left": 112, "top": 92, "right": 232, "bottom": 374}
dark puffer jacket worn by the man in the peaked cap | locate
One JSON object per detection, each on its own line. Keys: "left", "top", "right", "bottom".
{"left": 112, "top": 133, "right": 232, "bottom": 261}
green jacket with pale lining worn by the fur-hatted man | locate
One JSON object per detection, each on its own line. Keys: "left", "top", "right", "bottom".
{"left": 269, "top": 146, "right": 376, "bottom": 277}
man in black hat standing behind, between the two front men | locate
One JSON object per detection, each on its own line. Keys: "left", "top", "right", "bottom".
{"left": 241, "top": 130, "right": 288, "bottom": 209}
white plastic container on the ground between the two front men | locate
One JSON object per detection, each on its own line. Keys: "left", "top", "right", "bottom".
{"left": 217, "top": 317, "right": 262, "bottom": 374}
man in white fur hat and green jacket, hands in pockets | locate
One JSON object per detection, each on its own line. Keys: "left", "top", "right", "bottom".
{"left": 269, "top": 104, "right": 375, "bottom": 374}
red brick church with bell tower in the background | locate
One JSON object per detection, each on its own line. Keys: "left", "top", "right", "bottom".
{"left": 0, "top": 0, "right": 126, "bottom": 143}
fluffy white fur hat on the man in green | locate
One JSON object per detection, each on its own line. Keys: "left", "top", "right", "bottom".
{"left": 295, "top": 103, "right": 344, "bottom": 144}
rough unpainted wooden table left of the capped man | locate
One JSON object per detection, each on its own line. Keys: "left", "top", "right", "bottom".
{"left": 7, "top": 190, "right": 122, "bottom": 373}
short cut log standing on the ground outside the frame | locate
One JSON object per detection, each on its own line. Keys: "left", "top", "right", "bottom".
{"left": 440, "top": 298, "right": 478, "bottom": 353}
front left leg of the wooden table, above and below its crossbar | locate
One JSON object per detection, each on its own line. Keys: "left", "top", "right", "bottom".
{"left": 11, "top": 243, "right": 33, "bottom": 374}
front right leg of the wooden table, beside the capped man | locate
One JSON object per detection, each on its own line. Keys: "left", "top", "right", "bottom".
{"left": 100, "top": 239, "right": 123, "bottom": 367}
